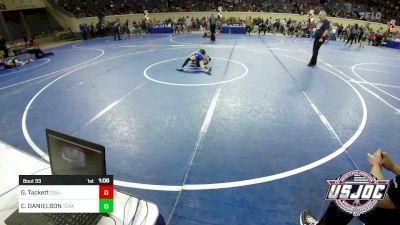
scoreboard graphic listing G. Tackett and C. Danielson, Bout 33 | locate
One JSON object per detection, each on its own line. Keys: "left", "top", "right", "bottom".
{"left": 18, "top": 175, "right": 114, "bottom": 213}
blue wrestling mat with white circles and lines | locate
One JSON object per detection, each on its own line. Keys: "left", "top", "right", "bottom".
{"left": 0, "top": 34, "right": 400, "bottom": 225}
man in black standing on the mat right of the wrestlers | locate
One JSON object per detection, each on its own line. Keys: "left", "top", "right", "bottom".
{"left": 308, "top": 11, "right": 330, "bottom": 66}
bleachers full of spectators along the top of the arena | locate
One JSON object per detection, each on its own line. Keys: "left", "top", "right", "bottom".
{"left": 54, "top": 0, "right": 400, "bottom": 23}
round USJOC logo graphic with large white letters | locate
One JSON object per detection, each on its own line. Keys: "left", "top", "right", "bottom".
{"left": 325, "top": 170, "right": 389, "bottom": 216}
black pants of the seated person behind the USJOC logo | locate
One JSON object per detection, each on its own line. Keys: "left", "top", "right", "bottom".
{"left": 318, "top": 202, "right": 400, "bottom": 225}
